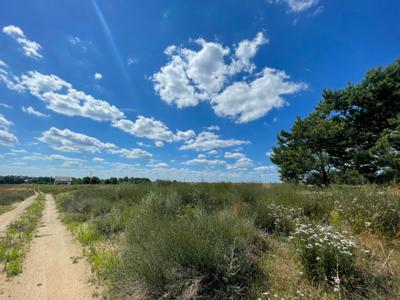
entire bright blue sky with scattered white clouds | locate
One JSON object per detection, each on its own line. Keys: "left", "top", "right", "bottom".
{"left": 0, "top": 0, "right": 400, "bottom": 182}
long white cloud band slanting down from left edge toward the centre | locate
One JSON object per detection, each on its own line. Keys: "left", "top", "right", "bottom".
{"left": 0, "top": 68, "right": 195, "bottom": 142}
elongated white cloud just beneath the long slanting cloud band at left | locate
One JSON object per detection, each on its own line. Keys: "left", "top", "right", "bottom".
{"left": 38, "top": 127, "right": 152, "bottom": 159}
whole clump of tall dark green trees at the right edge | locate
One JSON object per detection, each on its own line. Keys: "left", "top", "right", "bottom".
{"left": 271, "top": 60, "right": 400, "bottom": 185}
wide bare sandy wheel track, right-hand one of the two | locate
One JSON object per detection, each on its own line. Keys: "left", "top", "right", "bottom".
{"left": 0, "top": 195, "right": 94, "bottom": 300}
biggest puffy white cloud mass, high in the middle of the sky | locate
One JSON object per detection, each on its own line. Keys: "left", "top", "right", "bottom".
{"left": 151, "top": 32, "right": 306, "bottom": 123}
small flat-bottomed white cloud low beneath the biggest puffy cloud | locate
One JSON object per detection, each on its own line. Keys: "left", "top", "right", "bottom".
{"left": 179, "top": 131, "right": 250, "bottom": 151}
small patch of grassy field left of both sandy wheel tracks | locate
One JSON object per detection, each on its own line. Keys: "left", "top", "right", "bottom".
{"left": 0, "top": 184, "right": 33, "bottom": 214}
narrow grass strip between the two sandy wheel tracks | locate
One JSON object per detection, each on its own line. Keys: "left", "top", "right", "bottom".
{"left": 0, "top": 195, "right": 45, "bottom": 277}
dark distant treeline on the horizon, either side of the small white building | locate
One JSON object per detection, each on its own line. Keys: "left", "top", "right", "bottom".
{"left": 0, "top": 176, "right": 151, "bottom": 184}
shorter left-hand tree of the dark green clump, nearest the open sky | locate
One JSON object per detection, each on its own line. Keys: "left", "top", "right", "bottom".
{"left": 271, "top": 113, "right": 343, "bottom": 185}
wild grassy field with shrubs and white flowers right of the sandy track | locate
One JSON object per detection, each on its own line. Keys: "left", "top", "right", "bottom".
{"left": 41, "top": 182, "right": 400, "bottom": 299}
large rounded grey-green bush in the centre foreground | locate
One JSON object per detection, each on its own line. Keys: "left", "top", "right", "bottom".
{"left": 114, "top": 210, "right": 262, "bottom": 299}
